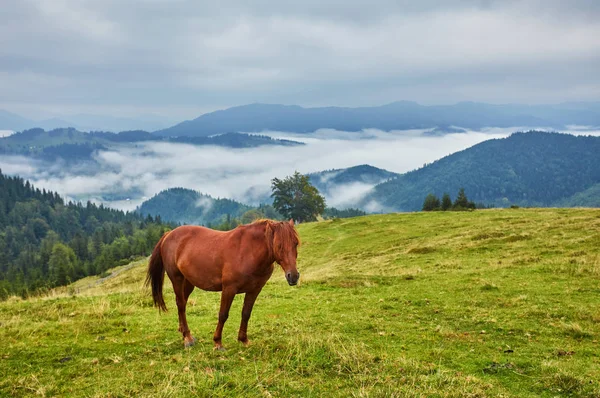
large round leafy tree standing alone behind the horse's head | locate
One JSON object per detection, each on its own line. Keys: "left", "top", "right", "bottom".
{"left": 271, "top": 171, "right": 325, "bottom": 222}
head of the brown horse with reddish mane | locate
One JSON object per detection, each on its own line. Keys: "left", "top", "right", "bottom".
{"left": 267, "top": 220, "right": 300, "bottom": 286}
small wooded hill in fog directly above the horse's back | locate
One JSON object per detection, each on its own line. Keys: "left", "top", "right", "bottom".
{"left": 136, "top": 188, "right": 252, "bottom": 225}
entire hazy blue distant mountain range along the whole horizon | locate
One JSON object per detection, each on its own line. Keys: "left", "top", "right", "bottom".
{"left": 5, "top": 101, "right": 600, "bottom": 137}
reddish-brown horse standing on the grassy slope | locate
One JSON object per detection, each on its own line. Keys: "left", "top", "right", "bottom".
{"left": 146, "top": 220, "right": 300, "bottom": 350}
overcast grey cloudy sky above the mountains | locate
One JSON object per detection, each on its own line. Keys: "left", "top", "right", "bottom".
{"left": 0, "top": 0, "right": 600, "bottom": 119}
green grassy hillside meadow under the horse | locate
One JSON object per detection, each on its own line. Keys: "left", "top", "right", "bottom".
{"left": 0, "top": 209, "right": 600, "bottom": 397}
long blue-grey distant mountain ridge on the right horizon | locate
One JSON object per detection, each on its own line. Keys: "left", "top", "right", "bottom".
{"left": 155, "top": 101, "right": 600, "bottom": 137}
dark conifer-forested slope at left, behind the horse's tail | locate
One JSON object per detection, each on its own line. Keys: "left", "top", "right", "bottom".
{"left": 0, "top": 171, "right": 168, "bottom": 299}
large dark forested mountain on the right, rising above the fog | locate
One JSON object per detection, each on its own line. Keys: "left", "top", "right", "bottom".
{"left": 361, "top": 131, "right": 600, "bottom": 211}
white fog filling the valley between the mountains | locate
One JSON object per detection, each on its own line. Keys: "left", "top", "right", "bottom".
{"left": 0, "top": 128, "right": 600, "bottom": 210}
